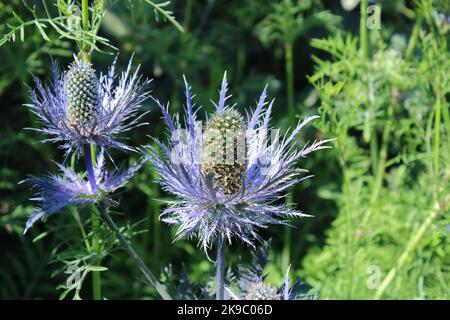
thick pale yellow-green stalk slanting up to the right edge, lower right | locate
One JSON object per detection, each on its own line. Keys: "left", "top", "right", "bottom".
{"left": 374, "top": 195, "right": 450, "bottom": 300}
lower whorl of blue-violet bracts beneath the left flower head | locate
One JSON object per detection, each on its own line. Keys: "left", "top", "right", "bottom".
{"left": 21, "top": 152, "right": 142, "bottom": 233}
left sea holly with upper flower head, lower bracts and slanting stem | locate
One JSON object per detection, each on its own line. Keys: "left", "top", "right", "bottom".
{"left": 23, "top": 53, "right": 171, "bottom": 299}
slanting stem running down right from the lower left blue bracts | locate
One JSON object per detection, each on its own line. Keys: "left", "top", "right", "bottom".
{"left": 97, "top": 205, "right": 172, "bottom": 300}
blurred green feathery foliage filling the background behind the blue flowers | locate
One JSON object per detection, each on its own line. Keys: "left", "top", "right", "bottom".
{"left": 0, "top": 0, "right": 450, "bottom": 299}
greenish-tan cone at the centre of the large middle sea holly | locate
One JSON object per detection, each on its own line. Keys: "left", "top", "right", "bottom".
{"left": 202, "top": 109, "right": 246, "bottom": 194}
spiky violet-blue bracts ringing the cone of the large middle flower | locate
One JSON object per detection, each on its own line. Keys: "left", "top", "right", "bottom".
{"left": 144, "top": 73, "right": 327, "bottom": 250}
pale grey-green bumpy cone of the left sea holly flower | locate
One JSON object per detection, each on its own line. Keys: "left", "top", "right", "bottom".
{"left": 65, "top": 62, "right": 98, "bottom": 129}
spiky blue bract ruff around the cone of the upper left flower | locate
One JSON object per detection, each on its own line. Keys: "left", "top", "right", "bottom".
{"left": 25, "top": 58, "right": 150, "bottom": 155}
